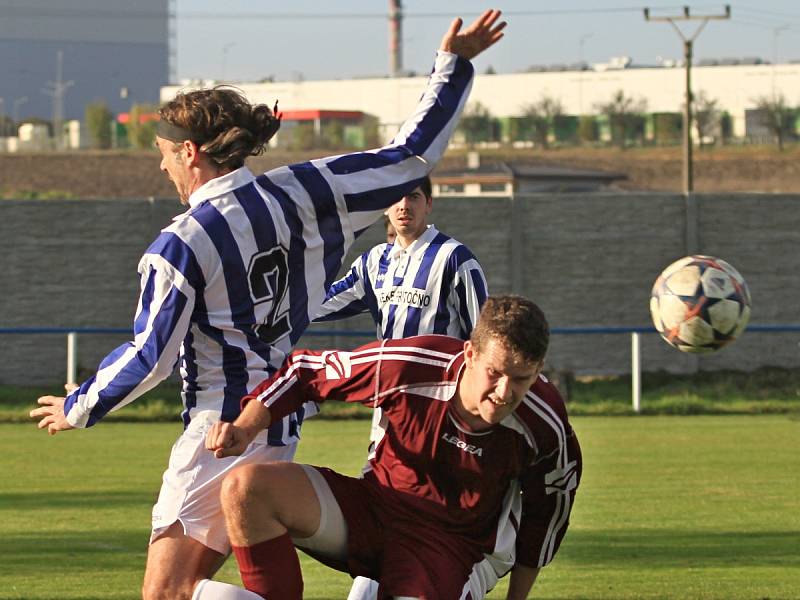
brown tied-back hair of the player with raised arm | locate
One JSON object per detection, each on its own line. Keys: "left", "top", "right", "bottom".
{"left": 158, "top": 86, "right": 280, "bottom": 170}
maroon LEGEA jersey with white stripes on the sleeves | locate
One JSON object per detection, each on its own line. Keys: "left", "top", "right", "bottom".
{"left": 244, "top": 335, "right": 582, "bottom": 575}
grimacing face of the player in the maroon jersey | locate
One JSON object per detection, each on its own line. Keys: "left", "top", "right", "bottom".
{"left": 459, "top": 339, "right": 543, "bottom": 426}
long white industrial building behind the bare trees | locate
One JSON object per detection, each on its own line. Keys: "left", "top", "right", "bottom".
{"left": 161, "top": 60, "right": 800, "bottom": 138}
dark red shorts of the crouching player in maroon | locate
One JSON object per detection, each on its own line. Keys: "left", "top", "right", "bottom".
{"left": 315, "top": 467, "right": 483, "bottom": 600}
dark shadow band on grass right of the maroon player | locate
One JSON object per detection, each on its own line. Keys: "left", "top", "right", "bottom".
{"left": 560, "top": 529, "right": 800, "bottom": 569}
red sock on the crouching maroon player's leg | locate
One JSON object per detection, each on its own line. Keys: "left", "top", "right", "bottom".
{"left": 233, "top": 533, "right": 303, "bottom": 600}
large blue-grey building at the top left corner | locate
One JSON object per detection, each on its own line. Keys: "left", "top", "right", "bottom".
{"left": 0, "top": 0, "right": 169, "bottom": 122}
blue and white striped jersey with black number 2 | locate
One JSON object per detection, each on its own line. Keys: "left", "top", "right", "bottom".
{"left": 64, "top": 52, "right": 473, "bottom": 445}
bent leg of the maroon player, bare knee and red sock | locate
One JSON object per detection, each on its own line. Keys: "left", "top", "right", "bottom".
{"left": 221, "top": 463, "right": 347, "bottom": 600}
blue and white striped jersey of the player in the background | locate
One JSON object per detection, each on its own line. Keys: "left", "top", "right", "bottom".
{"left": 316, "top": 225, "right": 487, "bottom": 340}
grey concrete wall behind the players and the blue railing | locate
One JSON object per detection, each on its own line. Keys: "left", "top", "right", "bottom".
{"left": 0, "top": 194, "right": 800, "bottom": 384}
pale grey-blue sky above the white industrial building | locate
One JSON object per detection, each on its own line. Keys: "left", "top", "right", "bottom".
{"left": 176, "top": 0, "right": 800, "bottom": 81}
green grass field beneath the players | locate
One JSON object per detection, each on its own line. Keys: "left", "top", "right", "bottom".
{"left": 0, "top": 415, "right": 800, "bottom": 600}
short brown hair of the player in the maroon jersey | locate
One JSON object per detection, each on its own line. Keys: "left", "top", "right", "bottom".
{"left": 469, "top": 296, "right": 550, "bottom": 362}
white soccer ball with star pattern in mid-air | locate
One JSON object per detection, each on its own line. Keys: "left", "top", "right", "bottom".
{"left": 650, "top": 255, "right": 750, "bottom": 352}
